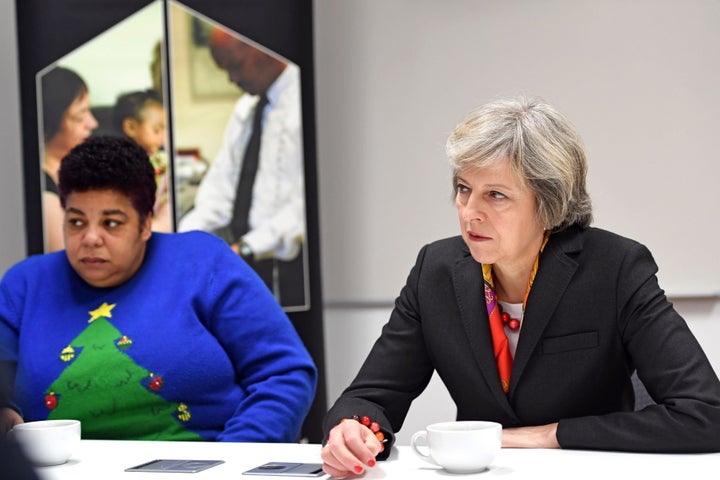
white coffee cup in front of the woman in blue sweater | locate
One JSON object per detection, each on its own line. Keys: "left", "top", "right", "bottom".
{"left": 10, "top": 420, "right": 80, "bottom": 466}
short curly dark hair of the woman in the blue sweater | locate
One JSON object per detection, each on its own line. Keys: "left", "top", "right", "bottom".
{"left": 58, "top": 136, "right": 156, "bottom": 222}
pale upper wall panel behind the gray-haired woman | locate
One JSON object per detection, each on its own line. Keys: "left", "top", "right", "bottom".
{"left": 315, "top": 0, "right": 720, "bottom": 301}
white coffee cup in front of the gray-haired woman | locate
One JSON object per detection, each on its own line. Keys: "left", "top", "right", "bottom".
{"left": 410, "top": 420, "right": 502, "bottom": 473}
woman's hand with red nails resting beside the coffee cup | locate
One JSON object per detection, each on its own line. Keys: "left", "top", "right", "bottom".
{"left": 320, "top": 420, "right": 384, "bottom": 478}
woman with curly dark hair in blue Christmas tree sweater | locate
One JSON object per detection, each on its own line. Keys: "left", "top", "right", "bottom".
{"left": 0, "top": 137, "right": 317, "bottom": 442}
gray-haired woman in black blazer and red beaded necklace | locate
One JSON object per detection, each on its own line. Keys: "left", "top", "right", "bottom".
{"left": 322, "top": 98, "right": 720, "bottom": 476}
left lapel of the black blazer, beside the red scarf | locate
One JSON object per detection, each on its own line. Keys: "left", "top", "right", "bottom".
{"left": 453, "top": 252, "right": 516, "bottom": 418}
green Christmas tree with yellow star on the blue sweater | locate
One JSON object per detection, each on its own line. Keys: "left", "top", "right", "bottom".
{"left": 45, "top": 303, "right": 202, "bottom": 440}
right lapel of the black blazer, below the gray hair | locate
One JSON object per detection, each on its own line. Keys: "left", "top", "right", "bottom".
{"left": 509, "top": 228, "right": 582, "bottom": 396}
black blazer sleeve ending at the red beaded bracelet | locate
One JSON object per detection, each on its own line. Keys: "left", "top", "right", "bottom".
{"left": 323, "top": 247, "right": 433, "bottom": 459}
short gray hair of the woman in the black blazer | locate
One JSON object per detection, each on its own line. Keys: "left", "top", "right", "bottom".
{"left": 446, "top": 97, "right": 592, "bottom": 231}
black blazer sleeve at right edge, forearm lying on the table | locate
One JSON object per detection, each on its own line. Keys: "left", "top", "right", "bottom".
{"left": 557, "top": 243, "right": 720, "bottom": 452}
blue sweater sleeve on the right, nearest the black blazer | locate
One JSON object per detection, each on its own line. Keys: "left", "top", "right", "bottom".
{"left": 203, "top": 244, "right": 317, "bottom": 442}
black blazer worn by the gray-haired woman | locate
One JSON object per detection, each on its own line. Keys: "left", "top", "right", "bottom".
{"left": 325, "top": 227, "right": 720, "bottom": 456}
